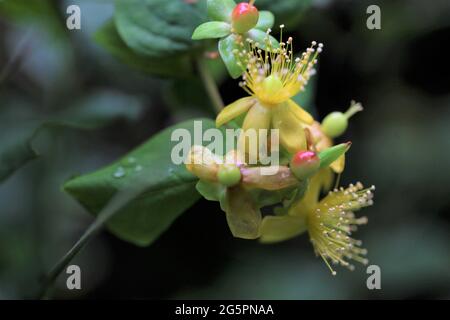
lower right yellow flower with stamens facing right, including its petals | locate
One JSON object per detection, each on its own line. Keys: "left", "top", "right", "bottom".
{"left": 260, "top": 171, "right": 375, "bottom": 275}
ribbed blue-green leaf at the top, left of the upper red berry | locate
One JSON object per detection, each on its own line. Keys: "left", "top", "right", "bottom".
{"left": 115, "top": 0, "right": 201, "bottom": 57}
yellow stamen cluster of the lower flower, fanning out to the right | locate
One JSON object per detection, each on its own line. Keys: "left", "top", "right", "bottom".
{"left": 307, "top": 182, "right": 375, "bottom": 275}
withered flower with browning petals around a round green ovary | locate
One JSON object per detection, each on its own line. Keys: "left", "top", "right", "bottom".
{"left": 185, "top": 146, "right": 299, "bottom": 239}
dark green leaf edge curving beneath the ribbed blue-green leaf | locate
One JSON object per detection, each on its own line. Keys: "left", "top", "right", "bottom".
{"left": 95, "top": 20, "right": 192, "bottom": 78}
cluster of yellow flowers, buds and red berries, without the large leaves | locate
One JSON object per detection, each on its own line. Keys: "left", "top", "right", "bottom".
{"left": 186, "top": 0, "right": 374, "bottom": 274}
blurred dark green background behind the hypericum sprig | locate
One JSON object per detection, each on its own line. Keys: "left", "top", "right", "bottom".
{"left": 0, "top": 0, "right": 450, "bottom": 299}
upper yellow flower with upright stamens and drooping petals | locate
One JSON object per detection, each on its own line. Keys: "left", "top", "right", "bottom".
{"left": 216, "top": 30, "right": 322, "bottom": 153}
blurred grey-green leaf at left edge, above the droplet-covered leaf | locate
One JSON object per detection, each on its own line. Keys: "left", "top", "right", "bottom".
{"left": 0, "top": 91, "right": 142, "bottom": 182}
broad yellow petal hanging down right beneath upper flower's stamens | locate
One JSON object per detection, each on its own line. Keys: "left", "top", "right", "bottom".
{"left": 272, "top": 103, "right": 306, "bottom": 153}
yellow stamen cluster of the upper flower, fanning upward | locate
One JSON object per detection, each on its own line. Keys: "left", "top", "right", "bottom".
{"left": 233, "top": 25, "right": 323, "bottom": 105}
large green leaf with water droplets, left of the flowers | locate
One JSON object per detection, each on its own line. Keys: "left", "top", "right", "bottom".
{"left": 64, "top": 119, "right": 215, "bottom": 246}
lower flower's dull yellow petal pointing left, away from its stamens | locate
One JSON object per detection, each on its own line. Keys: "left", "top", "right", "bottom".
{"left": 259, "top": 216, "right": 306, "bottom": 243}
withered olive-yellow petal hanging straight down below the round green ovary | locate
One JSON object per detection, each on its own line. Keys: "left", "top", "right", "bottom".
{"left": 225, "top": 186, "right": 262, "bottom": 239}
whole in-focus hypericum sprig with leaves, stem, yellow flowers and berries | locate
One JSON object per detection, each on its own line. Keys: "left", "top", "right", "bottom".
{"left": 32, "top": 0, "right": 374, "bottom": 291}
